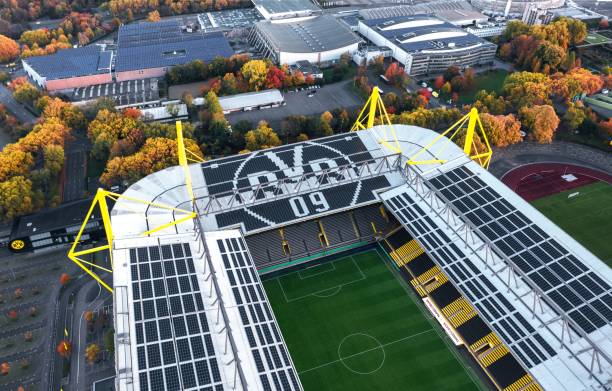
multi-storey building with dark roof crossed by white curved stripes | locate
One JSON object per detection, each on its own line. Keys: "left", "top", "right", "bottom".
{"left": 359, "top": 15, "right": 497, "bottom": 76}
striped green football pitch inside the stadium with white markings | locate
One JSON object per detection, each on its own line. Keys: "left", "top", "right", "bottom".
{"left": 264, "top": 250, "right": 486, "bottom": 391}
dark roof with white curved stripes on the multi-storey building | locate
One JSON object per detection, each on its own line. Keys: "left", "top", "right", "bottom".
{"left": 360, "top": 15, "right": 492, "bottom": 52}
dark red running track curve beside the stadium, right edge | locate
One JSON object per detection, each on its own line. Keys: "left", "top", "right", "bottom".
{"left": 502, "top": 163, "right": 612, "bottom": 201}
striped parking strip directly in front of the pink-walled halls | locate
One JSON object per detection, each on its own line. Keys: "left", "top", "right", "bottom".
{"left": 72, "top": 79, "right": 159, "bottom": 106}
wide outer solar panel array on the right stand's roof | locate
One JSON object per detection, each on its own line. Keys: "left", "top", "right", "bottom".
{"left": 431, "top": 166, "right": 612, "bottom": 333}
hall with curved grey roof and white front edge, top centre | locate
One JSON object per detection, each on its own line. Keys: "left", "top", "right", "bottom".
{"left": 249, "top": 15, "right": 361, "bottom": 65}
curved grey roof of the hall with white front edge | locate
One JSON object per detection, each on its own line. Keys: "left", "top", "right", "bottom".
{"left": 256, "top": 15, "right": 360, "bottom": 53}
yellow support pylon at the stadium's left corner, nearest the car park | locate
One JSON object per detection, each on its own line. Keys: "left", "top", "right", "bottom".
{"left": 68, "top": 189, "right": 196, "bottom": 293}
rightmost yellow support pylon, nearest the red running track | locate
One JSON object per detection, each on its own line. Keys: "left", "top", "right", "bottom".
{"left": 406, "top": 107, "right": 493, "bottom": 168}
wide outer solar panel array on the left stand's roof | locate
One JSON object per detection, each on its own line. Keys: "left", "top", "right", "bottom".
{"left": 130, "top": 244, "right": 223, "bottom": 391}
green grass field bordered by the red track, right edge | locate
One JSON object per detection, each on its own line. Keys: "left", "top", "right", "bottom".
{"left": 533, "top": 182, "right": 612, "bottom": 267}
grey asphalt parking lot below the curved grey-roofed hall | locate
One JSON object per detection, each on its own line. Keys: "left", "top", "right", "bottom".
{"left": 227, "top": 80, "right": 364, "bottom": 129}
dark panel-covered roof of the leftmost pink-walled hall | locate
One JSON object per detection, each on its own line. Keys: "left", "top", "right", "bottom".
{"left": 23, "top": 45, "right": 113, "bottom": 80}
